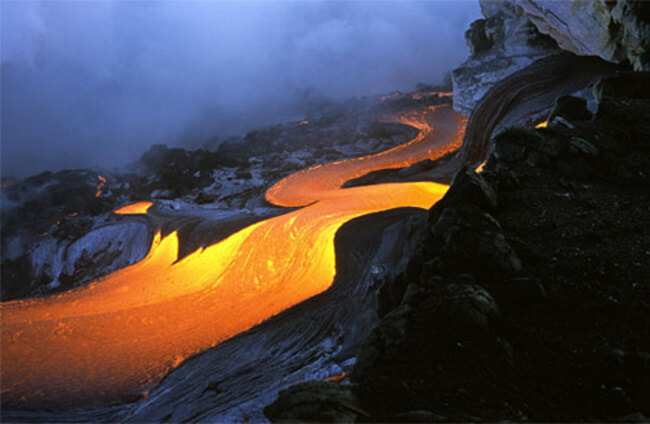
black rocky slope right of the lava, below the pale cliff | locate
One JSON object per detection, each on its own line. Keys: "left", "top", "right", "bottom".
{"left": 264, "top": 74, "right": 650, "bottom": 422}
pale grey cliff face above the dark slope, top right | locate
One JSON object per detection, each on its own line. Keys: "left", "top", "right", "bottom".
{"left": 452, "top": 0, "right": 650, "bottom": 115}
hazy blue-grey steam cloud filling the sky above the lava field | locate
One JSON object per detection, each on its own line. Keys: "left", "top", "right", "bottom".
{"left": 0, "top": 0, "right": 479, "bottom": 177}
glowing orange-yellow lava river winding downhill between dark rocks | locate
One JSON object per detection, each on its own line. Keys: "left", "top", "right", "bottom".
{"left": 0, "top": 102, "right": 464, "bottom": 408}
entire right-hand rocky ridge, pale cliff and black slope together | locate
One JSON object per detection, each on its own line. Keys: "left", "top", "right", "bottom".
{"left": 265, "top": 0, "right": 650, "bottom": 422}
